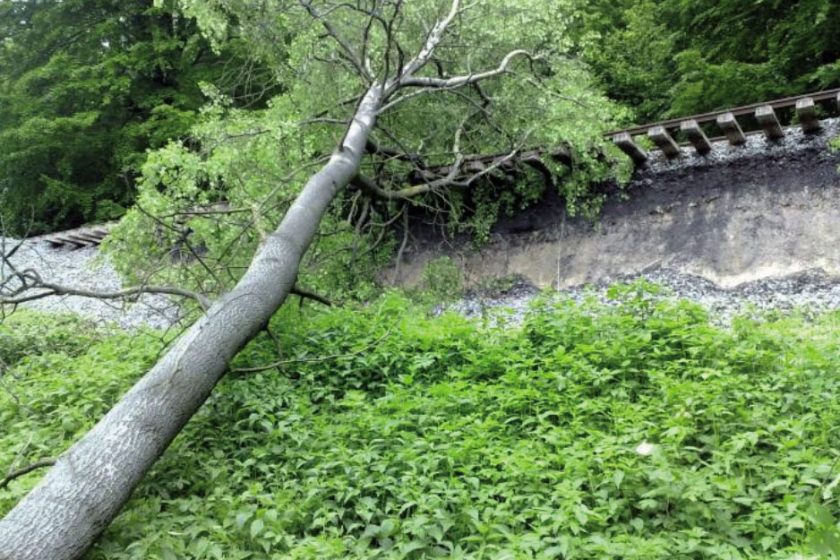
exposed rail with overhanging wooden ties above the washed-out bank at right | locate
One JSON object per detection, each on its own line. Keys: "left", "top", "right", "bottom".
{"left": 607, "top": 88, "right": 840, "bottom": 166}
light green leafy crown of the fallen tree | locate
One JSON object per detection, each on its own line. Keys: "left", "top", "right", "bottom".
{"left": 103, "top": 1, "right": 627, "bottom": 300}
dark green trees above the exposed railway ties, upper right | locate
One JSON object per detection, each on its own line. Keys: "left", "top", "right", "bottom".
{"left": 576, "top": 0, "right": 840, "bottom": 121}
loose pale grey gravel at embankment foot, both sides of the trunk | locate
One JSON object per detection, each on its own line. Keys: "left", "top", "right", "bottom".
{"left": 8, "top": 235, "right": 840, "bottom": 329}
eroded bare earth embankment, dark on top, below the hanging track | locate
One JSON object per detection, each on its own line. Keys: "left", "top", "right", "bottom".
{"left": 390, "top": 117, "right": 840, "bottom": 302}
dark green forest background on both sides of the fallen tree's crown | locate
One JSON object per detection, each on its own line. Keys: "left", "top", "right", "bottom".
{"left": 0, "top": 0, "right": 840, "bottom": 235}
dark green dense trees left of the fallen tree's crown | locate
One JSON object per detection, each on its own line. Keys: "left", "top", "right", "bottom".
{"left": 0, "top": 0, "right": 262, "bottom": 234}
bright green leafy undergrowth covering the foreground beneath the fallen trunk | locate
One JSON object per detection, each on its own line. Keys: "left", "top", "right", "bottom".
{"left": 0, "top": 285, "right": 840, "bottom": 560}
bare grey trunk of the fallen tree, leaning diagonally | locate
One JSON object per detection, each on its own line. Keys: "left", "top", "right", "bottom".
{"left": 0, "top": 83, "right": 385, "bottom": 560}
